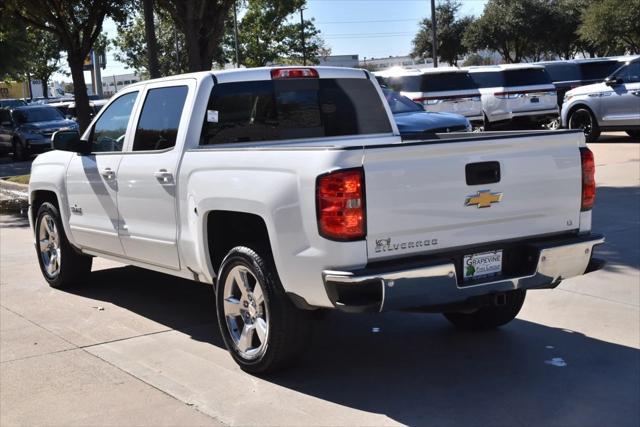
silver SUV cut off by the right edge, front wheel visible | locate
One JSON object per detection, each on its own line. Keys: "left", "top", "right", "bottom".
{"left": 562, "top": 57, "right": 640, "bottom": 142}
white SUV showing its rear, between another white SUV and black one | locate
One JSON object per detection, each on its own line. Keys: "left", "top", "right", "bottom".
{"left": 467, "top": 64, "right": 559, "bottom": 127}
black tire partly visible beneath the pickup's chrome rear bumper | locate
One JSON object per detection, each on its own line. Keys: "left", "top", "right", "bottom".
{"left": 443, "top": 290, "right": 527, "bottom": 331}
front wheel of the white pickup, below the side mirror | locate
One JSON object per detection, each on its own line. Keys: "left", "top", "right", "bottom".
{"left": 35, "top": 202, "right": 93, "bottom": 289}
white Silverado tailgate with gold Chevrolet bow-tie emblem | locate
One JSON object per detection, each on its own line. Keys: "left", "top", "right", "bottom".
{"left": 364, "top": 132, "right": 582, "bottom": 259}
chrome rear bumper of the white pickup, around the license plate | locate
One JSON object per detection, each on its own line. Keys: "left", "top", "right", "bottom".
{"left": 323, "top": 235, "right": 604, "bottom": 312}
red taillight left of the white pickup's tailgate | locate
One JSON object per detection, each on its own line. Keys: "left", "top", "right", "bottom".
{"left": 316, "top": 168, "right": 366, "bottom": 240}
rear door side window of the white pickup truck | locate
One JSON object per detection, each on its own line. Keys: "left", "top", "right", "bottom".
{"left": 133, "top": 86, "right": 189, "bottom": 151}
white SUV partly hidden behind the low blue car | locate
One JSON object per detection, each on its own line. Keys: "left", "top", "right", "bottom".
{"left": 376, "top": 67, "right": 484, "bottom": 128}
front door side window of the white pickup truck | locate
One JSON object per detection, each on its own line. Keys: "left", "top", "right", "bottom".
{"left": 91, "top": 92, "right": 138, "bottom": 152}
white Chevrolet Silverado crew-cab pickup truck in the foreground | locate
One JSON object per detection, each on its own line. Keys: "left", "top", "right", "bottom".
{"left": 29, "top": 67, "right": 604, "bottom": 373}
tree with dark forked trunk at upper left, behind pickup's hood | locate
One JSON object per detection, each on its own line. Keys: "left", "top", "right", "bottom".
{"left": 6, "top": 0, "right": 129, "bottom": 131}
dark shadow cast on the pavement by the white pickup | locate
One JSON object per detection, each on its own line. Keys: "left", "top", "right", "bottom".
{"left": 66, "top": 267, "right": 640, "bottom": 426}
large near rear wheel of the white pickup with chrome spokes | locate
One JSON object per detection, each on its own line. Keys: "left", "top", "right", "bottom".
{"left": 216, "top": 246, "right": 311, "bottom": 374}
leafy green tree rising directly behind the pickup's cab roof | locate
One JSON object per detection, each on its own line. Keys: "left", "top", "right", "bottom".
{"left": 238, "top": 0, "right": 324, "bottom": 67}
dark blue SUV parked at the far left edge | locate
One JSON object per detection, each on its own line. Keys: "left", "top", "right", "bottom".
{"left": 0, "top": 105, "right": 78, "bottom": 160}
